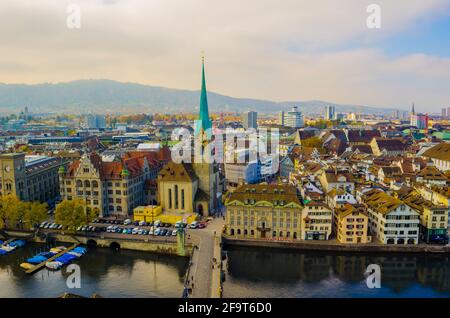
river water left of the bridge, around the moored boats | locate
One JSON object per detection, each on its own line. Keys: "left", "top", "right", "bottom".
{"left": 0, "top": 244, "right": 189, "bottom": 298}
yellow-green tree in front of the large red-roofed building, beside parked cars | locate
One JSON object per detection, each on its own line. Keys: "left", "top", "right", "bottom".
{"left": 55, "top": 199, "right": 99, "bottom": 229}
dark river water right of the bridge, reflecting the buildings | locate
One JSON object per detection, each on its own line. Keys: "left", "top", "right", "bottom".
{"left": 223, "top": 247, "right": 450, "bottom": 298}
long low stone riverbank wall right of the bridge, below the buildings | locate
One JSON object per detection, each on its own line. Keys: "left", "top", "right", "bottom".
{"left": 223, "top": 236, "right": 450, "bottom": 254}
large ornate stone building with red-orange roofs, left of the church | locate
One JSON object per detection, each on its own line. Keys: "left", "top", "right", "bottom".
{"left": 59, "top": 152, "right": 161, "bottom": 217}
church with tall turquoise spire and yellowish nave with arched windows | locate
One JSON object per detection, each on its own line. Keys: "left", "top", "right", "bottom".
{"left": 158, "top": 61, "right": 222, "bottom": 216}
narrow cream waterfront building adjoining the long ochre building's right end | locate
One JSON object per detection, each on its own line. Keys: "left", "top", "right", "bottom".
{"left": 301, "top": 200, "right": 333, "bottom": 241}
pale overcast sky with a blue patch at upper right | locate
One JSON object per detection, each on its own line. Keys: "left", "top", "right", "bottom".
{"left": 0, "top": 0, "right": 450, "bottom": 112}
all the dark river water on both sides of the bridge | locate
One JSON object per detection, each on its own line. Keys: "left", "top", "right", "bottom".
{"left": 0, "top": 244, "right": 450, "bottom": 298}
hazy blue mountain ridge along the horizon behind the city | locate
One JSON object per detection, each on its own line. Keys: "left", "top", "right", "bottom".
{"left": 0, "top": 79, "right": 404, "bottom": 114}
